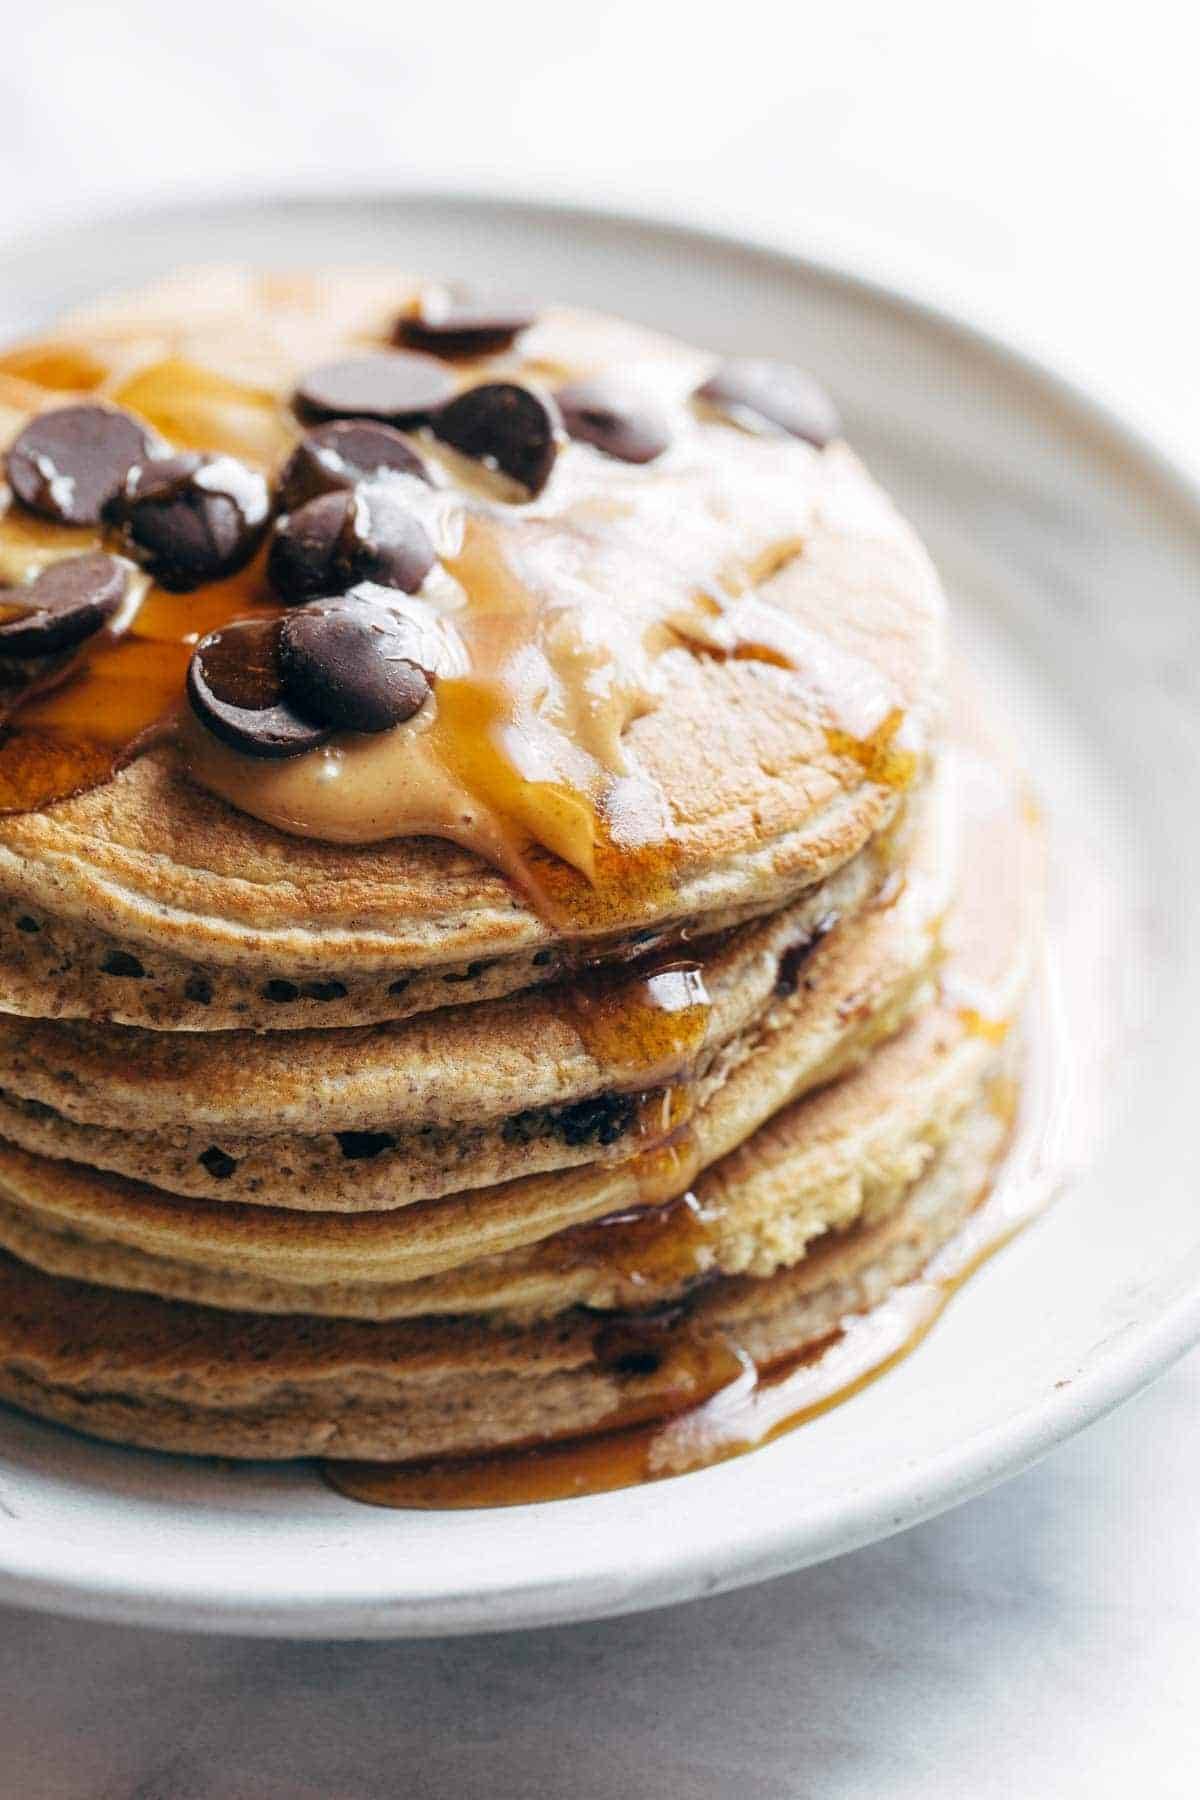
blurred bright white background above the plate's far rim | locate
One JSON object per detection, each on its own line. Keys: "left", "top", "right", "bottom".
{"left": 0, "top": 0, "right": 1200, "bottom": 452}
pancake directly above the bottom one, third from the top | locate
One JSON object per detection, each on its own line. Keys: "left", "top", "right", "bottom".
{"left": 0, "top": 705, "right": 1040, "bottom": 1318}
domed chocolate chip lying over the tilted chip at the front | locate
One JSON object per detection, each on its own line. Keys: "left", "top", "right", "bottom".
{"left": 279, "top": 596, "right": 430, "bottom": 731}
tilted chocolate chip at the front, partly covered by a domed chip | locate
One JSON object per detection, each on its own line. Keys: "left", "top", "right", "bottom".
{"left": 187, "top": 619, "right": 329, "bottom": 759}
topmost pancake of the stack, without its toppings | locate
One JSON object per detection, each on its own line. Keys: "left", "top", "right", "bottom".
{"left": 0, "top": 270, "right": 943, "bottom": 1030}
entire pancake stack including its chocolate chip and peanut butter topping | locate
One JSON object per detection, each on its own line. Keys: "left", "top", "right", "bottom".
{"left": 0, "top": 270, "right": 1040, "bottom": 1474}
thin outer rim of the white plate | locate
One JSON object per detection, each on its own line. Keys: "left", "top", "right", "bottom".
{"left": 0, "top": 184, "right": 1200, "bottom": 1638}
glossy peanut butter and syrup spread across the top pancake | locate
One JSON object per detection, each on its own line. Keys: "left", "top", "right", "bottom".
{"left": 0, "top": 318, "right": 914, "bottom": 927}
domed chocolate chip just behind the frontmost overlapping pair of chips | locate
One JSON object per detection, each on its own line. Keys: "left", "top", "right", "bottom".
{"left": 266, "top": 484, "right": 435, "bottom": 601}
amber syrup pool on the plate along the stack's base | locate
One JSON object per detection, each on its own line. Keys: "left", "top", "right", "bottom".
{"left": 329, "top": 1091, "right": 1049, "bottom": 1510}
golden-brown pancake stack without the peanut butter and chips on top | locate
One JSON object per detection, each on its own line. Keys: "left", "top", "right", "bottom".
{"left": 0, "top": 274, "right": 1036, "bottom": 1460}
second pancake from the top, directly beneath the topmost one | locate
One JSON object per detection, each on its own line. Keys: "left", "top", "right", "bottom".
{"left": 0, "top": 783, "right": 954, "bottom": 1211}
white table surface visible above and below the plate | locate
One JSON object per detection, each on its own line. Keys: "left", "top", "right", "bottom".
{"left": 0, "top": 0, "right": 1200, "bottom": 1800}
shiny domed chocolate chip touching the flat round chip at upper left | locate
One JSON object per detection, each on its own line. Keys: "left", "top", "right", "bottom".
{"left": 104, "top": 455, "right": 270, "bottom": 594}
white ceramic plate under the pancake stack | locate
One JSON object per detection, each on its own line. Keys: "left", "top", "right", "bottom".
{"left": 0, "top": 196, "right": 1200, "bottom": 1636}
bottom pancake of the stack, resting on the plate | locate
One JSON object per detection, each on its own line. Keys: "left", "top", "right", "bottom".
{"left": 0, "top": 1080, "right": 1007, "bottom": 1460}
